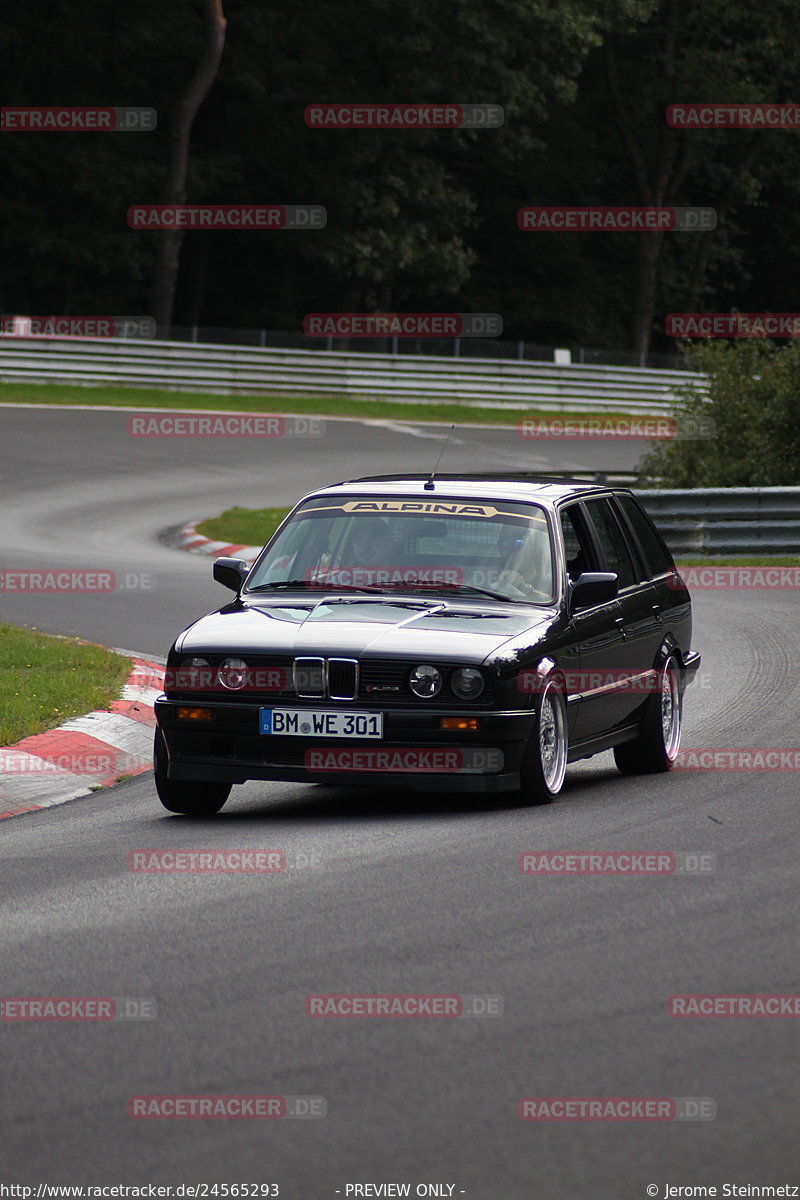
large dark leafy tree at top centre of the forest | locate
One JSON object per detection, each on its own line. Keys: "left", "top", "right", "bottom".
{"left": 231, "top": 0, "right": 619, "bottom": 324}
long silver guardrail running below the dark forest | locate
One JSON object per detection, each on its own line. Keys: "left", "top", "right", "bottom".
{"left": 0, "top": 337, "right": 704, "bottom": 413}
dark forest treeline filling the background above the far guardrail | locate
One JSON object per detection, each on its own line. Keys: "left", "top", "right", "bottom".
{"left": 0, "top": 0, "right": 800, "bottom": 352}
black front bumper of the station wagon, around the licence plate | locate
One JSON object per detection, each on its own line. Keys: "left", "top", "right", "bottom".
{"left": 154, "top": 696, "right": 534, "bottom": 792}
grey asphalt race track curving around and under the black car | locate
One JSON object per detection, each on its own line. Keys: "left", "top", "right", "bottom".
{"left": 0, "top": 408, "right": 800, "bottom": 1200}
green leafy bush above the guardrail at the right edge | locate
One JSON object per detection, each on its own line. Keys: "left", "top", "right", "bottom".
{"left": 639, "top": 338, "right": 800, "bottom": 487}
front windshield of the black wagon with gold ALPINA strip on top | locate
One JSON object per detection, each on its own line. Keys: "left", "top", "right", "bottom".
{"left": 246, "top": 496, "right": 553, "bottom": 604}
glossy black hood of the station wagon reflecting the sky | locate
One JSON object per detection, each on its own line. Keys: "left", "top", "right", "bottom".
{"left": 175, "top": 596, "right": 554, "bottom": 664}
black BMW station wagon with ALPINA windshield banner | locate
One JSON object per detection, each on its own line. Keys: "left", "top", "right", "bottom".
{"left": 155, "top": 474, "right": 700, "bottom": 814}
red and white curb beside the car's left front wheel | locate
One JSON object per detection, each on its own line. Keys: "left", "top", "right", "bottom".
{"left": 0, "top": 658, "right": 164, "bottom": 820}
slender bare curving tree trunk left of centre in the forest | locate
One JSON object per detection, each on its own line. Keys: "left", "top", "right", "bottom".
{"left": 150, "top": 0, "right": 228, "bottom": 337}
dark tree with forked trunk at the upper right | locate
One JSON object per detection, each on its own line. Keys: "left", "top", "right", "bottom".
{"left": 604, "top": 0, "right": 800, "bottom": 354}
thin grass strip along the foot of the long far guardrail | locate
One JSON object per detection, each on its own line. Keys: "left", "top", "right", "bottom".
{"left": 0, "top": 383, "right": 662, "bottom": 427}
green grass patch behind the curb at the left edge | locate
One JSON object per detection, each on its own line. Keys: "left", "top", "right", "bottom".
{"left": 0, "top": 624, "right": 131, "bottom": 746}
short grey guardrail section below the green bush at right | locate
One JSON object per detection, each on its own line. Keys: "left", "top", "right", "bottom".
{"left": 636, "top": 487, "right": 800, "bottom": 557}
